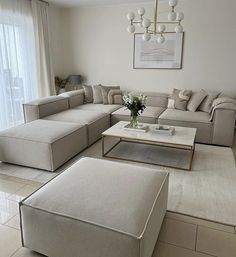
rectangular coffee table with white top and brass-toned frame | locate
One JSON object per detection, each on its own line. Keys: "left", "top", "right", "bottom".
{"left": 102, "top": 121, "right": 197, "bottom": 170}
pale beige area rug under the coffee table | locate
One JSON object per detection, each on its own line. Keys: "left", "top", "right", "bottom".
{"left": 0, "top": 141, "right": 236, "bottom": 226}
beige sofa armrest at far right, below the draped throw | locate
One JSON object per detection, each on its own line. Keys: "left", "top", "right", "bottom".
{"left": 212, "top": 109, "right": 235, "bottom": 146}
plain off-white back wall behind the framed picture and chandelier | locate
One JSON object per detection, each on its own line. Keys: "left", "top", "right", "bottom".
{"left": 55, "top": 0, "right": 236, "bottom": 96}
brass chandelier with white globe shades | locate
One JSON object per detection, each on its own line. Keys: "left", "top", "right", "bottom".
{"left": 127, "top": 0, "right": 184, "bottom": 44}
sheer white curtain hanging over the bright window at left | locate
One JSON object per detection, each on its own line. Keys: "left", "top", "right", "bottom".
{"left": 0, "top": 0, "right": 38, "bottom": 130}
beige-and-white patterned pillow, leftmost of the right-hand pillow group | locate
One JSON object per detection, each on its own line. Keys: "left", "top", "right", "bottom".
{"left": 168, "top": 88, "right": 192, "bottom": 111}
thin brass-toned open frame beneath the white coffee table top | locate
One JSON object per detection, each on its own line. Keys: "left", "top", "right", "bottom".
{"left": 102, "top": 135, "right": 195, "bottom": 171}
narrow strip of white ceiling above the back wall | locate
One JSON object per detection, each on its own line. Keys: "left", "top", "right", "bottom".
{"left": 47, "top": 0, "right": 153, "bottom": 7}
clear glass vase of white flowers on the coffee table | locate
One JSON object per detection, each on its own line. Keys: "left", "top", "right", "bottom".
{"left": 123, "top": 94, "right": 147, "bottom": 128}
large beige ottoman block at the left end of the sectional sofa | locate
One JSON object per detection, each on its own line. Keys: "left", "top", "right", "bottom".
{"left": 0, "top": 120, "right": 87, "bottom": 171}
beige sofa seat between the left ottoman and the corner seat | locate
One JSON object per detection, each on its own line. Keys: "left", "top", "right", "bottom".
{"left": 44, "top": 109, "right": 110, "bottom": 145}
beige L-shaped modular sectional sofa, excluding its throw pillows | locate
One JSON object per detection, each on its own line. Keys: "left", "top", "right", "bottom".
{"left": 0, "top": 90, "right": 235, "bottom": 171}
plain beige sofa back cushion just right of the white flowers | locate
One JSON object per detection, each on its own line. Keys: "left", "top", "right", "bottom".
{"left": 132, "top": 92, "right": 169, "bottom": 108}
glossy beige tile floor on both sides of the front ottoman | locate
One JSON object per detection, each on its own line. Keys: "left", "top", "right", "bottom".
{"left": 0, "top": 132, "right": 236, "bottom": 257}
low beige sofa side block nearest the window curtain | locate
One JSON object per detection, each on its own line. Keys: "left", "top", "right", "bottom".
{"left": 23, "top": 96, "right": 69, "bottom": 122}
